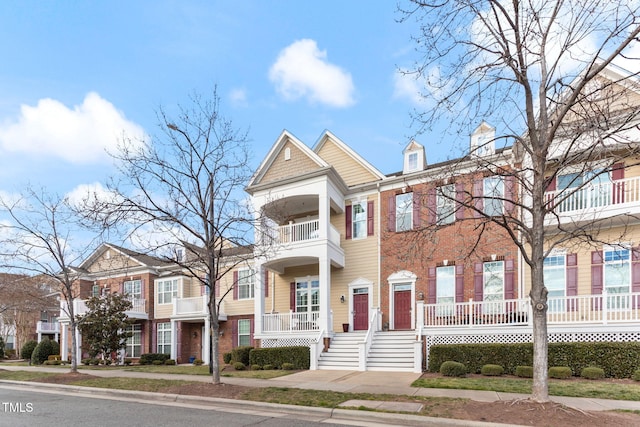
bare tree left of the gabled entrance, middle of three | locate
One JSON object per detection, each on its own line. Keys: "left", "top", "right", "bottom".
{"left": 86, "top": 90, "right": 254, "bottom": 384}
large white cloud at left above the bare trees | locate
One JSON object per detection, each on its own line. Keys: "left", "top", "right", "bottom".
{"left": 0, "top": 92, "right": 144, "bottom": 164}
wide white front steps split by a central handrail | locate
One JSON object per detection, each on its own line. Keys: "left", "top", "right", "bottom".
{"left": 318, "top": 331, "right": 416, "bottom": 372}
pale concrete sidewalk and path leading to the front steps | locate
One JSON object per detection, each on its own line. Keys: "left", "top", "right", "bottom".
{"left": 0, "top": 364, "right": 640, "bottom": 411}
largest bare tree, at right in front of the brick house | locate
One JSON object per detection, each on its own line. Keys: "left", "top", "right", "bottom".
{"left": 401, "top": 0, "right": 640, "bottom": 402}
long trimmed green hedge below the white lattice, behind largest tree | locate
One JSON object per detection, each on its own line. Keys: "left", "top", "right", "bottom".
{"left": 427, "top": 342, "right": 640, "bottom": 378}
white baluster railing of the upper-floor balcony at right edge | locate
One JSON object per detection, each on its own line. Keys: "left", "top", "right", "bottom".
{"left": 545, "top": 177, "right": 640, "bottom": 213}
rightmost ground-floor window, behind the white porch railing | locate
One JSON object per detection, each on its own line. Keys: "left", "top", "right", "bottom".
{"left": 603, "top": 247, "right": 631, "bottom": 310}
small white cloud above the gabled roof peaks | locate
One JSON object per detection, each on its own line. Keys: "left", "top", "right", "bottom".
{"left": 269, "top": 39, "right": 355, "bottom": 108}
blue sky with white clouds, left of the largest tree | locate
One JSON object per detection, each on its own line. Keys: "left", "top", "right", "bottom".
{"left": 0, "top": 0, "right": 457, "bottom": 200}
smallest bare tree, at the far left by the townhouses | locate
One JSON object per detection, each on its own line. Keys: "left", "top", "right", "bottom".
{"left": 0, "top": 188, "right": 98, "bottom": 372}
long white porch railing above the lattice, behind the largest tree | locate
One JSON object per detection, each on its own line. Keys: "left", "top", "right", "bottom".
{"left": 418, "top": 290, "right": 640, "bottom": 328}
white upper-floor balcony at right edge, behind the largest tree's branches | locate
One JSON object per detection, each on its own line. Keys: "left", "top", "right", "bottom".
{"left": 545, "top": 177, "right": 640, "bottom": 221}
